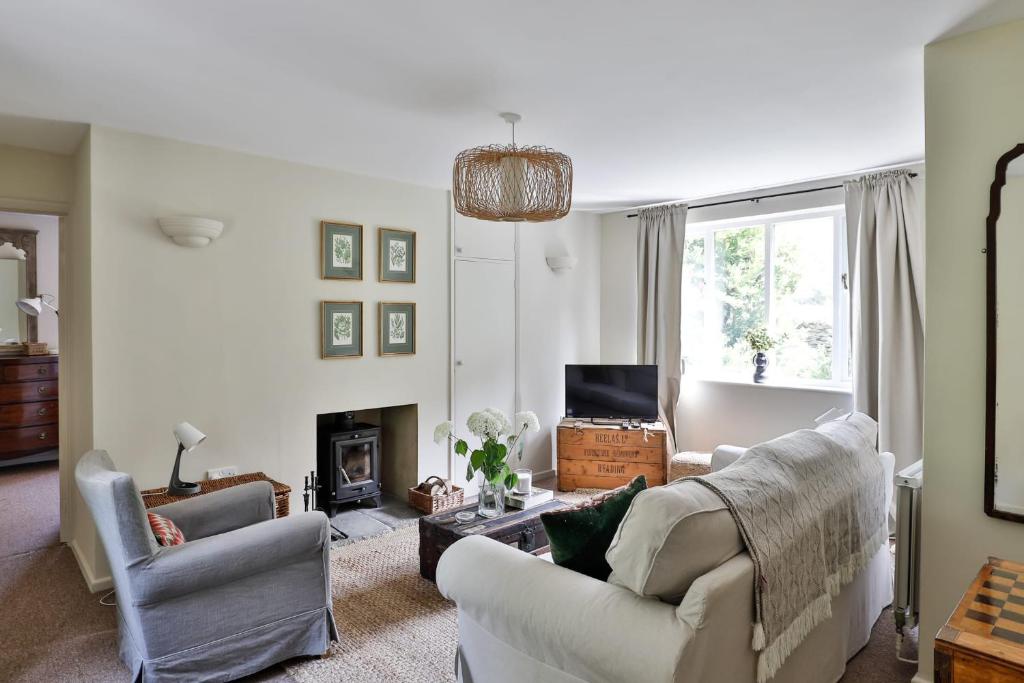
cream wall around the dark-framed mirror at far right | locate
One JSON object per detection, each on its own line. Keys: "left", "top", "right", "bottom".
{"left": 920, "top": 22, "right": 1024, "bottom": 680}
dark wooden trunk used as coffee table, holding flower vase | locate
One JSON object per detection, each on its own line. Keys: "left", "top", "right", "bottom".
{"left": 420, "top": 501, "right": 569, "bottom": 581}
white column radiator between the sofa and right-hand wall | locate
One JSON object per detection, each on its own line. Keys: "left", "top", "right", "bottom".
{"left": 893, "top": 460, "right": 924, "bottom": 634}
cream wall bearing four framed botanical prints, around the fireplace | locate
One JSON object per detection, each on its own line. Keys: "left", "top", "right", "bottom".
{"left": 76, "top": 128, "right": 449, "bottom": 589}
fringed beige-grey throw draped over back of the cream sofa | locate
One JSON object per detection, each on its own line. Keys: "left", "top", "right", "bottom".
{"left": 692, "top": 414, "right": 888, "bottom": 683}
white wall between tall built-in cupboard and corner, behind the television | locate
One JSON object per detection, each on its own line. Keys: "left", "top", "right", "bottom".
{"left": 519, "top": 213, "right": 602, "bottom": 473}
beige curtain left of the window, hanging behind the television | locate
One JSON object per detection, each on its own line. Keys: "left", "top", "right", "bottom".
{"left": 637, "top": 204, "right": 686, "bottom": 462}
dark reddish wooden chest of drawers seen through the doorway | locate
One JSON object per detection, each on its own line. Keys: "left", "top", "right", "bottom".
{"left": 0, "top": 355, "right": 58, "bottom": 460}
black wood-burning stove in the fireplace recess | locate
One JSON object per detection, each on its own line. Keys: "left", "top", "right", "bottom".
{"left": 316, "top": 419, "right": 381, "bottom": 515}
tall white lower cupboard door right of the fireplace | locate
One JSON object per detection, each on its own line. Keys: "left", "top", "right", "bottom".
{"left": 453, "top": 259, "right": 516, "bottom": 494}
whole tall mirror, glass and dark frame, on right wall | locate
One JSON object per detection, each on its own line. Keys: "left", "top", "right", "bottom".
{"left": 985, "top": 143, "right": 1024, "bottom": 521}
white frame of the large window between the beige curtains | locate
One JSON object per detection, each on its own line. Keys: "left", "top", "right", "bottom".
{"left": 680, "top": 204, "right": 852, "bottom": 391}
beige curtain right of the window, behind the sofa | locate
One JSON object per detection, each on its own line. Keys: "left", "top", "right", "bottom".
{"left": 845, "top": 171, "right": 925, "bottom": 471}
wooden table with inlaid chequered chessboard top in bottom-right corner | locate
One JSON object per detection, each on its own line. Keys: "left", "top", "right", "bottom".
{"left": 935, "top": 557, "right": 1024, "bottom": 683}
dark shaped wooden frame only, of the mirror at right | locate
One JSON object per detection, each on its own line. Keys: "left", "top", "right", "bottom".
{"left": 985, "top": 142, "right": 1024, "bottom": 522}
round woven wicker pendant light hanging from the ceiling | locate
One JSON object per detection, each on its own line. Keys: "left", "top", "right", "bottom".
{"left": 452, "top": 113, "right": 572, "bottom": 223}
